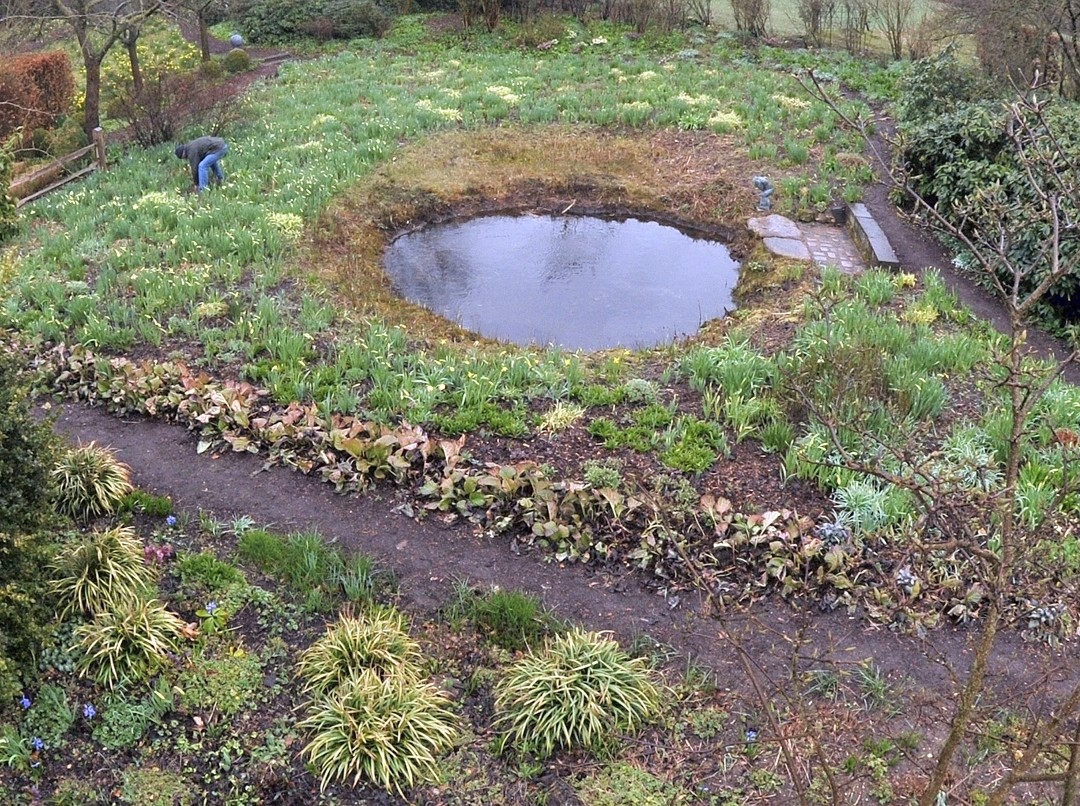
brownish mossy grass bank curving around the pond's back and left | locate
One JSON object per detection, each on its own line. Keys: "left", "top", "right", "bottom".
{"left": 303, "top": 125, "right": 760, "bottom": 345}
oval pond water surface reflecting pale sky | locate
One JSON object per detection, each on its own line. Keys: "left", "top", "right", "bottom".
{"left": 383, "top": 215, "right": 739, "bottom": 350}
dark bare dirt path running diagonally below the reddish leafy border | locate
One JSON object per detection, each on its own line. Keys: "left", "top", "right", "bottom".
{"left": 48, "top": 404, "right": 1071, "bottom": 723}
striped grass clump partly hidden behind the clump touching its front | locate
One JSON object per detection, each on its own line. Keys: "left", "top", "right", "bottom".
{"left": 298, "top": 607, "right": 422, "bottom": 698}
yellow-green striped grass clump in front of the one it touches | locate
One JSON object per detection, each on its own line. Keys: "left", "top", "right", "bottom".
{"left": 299, "top": 669, "right": 459, "bottom": 796}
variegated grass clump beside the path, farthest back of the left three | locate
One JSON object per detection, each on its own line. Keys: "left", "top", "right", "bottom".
{"left": 53, "top": 442, "right": 133, "bottom": 521}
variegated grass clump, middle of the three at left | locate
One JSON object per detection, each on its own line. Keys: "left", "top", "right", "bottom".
{"left": 51, "top": 526, "right": 153, "bottom": 618}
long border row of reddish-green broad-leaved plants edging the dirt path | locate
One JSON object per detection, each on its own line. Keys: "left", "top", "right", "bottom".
{"left": 19, "top": 334, "right": 1069, "bottom": 640}
